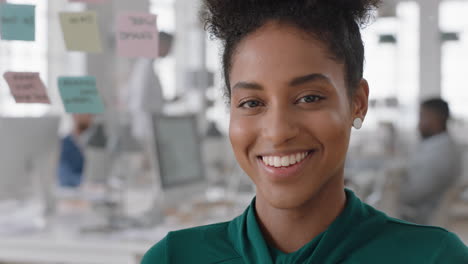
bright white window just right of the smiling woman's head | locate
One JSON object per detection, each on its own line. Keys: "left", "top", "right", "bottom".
{"left": 362, "top": 2, "right": 419, "bottom": 128}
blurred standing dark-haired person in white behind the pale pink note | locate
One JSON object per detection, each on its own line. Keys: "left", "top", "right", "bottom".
{"left": 123, "top": 32, "right": 174, "bottom": 142}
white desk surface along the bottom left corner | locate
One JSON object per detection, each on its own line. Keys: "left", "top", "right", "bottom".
{"left": 0, "top": 230, "right": 157, "bottom": 264}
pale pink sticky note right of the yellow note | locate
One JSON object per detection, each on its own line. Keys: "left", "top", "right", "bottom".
{"left": 116, "top": 12, "right": 158, "bottom": 58}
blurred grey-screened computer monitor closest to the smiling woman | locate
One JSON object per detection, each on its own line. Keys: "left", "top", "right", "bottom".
{"left": 152, "top": 115, "right": 207, "bottom": 205}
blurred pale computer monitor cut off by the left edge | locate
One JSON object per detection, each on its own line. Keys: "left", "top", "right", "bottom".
{"left": 0, "top": 117, "right": 60, "bottom": 207}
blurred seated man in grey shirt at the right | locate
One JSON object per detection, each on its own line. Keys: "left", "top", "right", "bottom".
{"left": 400, "top": 98, "right": 461, "bottom": 224}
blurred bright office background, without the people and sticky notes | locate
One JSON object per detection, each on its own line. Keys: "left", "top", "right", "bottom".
{"left": 0, "top": 0, "right": 468, "bottom": 264}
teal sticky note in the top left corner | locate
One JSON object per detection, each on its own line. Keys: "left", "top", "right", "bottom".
{"left": 0, "top": 4, "right": 36, "bottom": 41}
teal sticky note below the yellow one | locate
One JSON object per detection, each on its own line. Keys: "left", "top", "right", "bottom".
{"left": 58, "top": 76, "right": 104, "bottom": 114}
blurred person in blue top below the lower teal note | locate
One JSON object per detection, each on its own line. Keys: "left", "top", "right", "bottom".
{"left": 58, "top": 114, "right": 93, "bottom": 188}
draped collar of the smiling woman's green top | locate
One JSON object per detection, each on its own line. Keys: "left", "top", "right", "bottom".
{"left": 228, "top": 190, "right": 387, "bottom": 264}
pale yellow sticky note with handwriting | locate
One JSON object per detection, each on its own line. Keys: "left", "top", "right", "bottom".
{"left": 59, "top": 11, "right": 102, "bottom": 53}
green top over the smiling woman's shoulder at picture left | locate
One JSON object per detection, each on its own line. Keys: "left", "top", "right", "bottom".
{"left": 141, "top": 222, "right": 240, "bottom": 264}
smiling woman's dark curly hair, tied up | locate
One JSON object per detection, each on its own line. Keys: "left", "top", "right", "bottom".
{"left": 201, "top": 0, "right": 380, "bottom": 100}
